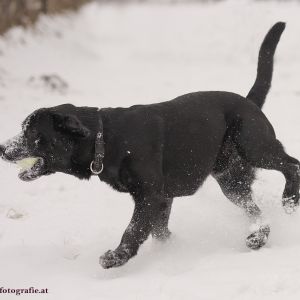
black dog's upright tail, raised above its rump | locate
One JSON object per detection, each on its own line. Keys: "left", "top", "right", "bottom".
{"left": 246, "top": 22, "right": 285, "bottom": 108}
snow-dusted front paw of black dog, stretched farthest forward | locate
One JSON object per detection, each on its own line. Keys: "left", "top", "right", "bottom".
{"left": 99, "top": 249, "right": 130, "bottom": 269}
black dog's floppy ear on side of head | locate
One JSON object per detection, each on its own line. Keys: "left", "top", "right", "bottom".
{"left": 53, "top": 113, "right": 90, "bottom": 138}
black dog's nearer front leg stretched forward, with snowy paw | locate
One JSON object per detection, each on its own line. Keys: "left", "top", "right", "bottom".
{"left": 100, "top": 195, "right": 161, "bottom": 269}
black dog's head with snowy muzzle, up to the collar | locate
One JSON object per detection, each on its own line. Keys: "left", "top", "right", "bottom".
{"left": 0, "top": 104, "right": 96, "bottom": 181}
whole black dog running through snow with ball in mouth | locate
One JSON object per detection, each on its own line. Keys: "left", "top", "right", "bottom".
{"left": 1, "top": 23, "right": 300, "bottom": 268}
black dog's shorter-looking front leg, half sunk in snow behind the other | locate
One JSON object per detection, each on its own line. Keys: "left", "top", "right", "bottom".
{"left": 151, "top": 198, "right": 173, "bottom": 241}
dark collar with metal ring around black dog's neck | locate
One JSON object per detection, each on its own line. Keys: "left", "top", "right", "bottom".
{"left": 90, "top": 113, "right": 104, "bottom": 175}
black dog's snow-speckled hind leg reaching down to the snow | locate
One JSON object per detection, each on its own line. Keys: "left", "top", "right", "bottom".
{"left": 213, "top": 151, "right": 270, "bottom": 250}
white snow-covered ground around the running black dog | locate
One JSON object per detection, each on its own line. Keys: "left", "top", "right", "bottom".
{"left": 0, "top": 0, "right": 300, "bottom": 300}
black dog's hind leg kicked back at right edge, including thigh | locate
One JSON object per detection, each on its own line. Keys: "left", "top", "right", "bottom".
{"left": 235, "top": 113, "right": 300, "bottom": 213}
